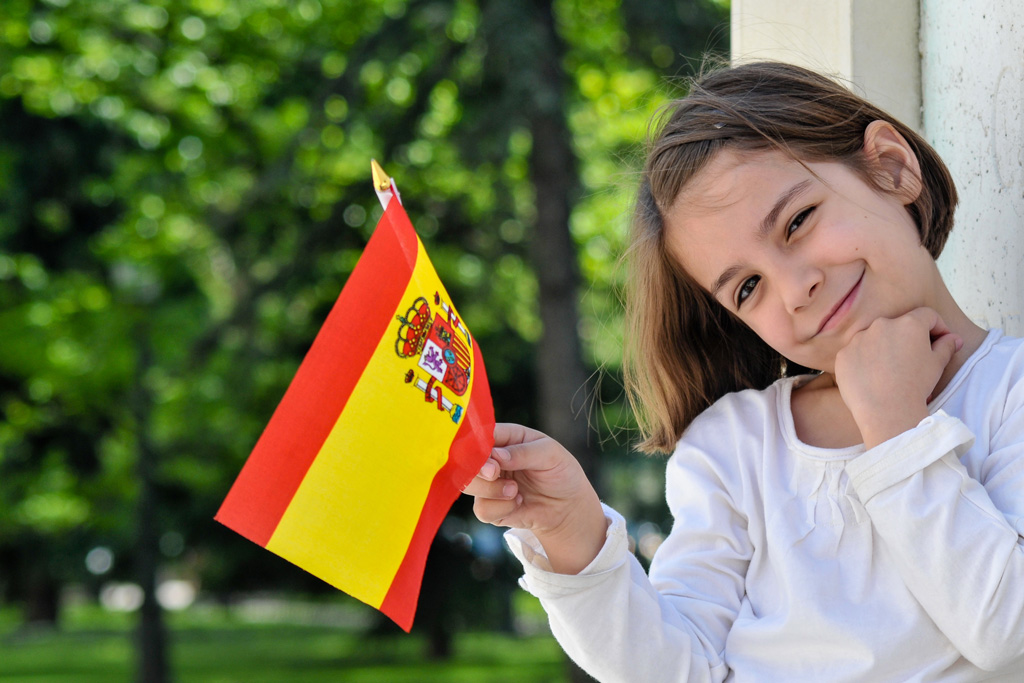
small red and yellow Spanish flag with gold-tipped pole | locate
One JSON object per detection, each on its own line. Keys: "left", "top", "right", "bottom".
{"left": 216, "top": 163, "right": 495, "bottom": 632}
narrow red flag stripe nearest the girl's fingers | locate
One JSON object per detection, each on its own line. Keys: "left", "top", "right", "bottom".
{"left": 380, "top": 343, "right": 495, "bottom": 633}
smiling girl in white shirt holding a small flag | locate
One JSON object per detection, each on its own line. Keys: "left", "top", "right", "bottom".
{"left": 466, "top": 63, "right": 1024, "bottom": 683}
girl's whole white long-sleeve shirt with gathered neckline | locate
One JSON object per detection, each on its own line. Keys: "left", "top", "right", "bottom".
{"left": 506, "top": 331, "right": 1024, "bottom": 683}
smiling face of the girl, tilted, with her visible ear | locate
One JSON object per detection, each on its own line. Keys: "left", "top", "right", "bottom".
{"left": 667, "top": 141, "right": 943, "bottom": 373}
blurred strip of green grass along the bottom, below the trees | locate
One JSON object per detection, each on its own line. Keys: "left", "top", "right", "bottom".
{"left": 0, "top": 593, "right": 567, "bottom": 683}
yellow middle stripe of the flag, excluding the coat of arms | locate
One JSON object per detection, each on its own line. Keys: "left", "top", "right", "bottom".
{"left": 266, "top": 240, "right": 475, "bottom": 607}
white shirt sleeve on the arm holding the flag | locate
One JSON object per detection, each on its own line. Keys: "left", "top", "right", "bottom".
{"left": 506, "top": 438, "right": 752, "bottom": 683}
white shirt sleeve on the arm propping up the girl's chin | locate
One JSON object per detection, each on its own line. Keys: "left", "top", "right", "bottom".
{"left": 847, "top": 409, "right": 1024, "bottom": 671}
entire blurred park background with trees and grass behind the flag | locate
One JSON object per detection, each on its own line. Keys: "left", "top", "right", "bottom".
{"left": 0, "top": 0, "right": 729, "bottom": 683}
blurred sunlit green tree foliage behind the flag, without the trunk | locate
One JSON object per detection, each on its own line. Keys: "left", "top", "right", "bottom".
{"left": 0, "top": 0, "right": 727, "bottom": 626}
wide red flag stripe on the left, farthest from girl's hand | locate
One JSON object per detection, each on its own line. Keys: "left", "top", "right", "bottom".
{"left": 215, "top": 199, "right": 418, "bottom": 547}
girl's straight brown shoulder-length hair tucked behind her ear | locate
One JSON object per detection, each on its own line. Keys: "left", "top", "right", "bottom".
{"left": 624, "top": 62, "right": 956, "bottom": 453}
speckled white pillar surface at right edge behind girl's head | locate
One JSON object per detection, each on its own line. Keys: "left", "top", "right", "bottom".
{"left": 921, "top": 0, "right": 1024, "bottom": 336}
